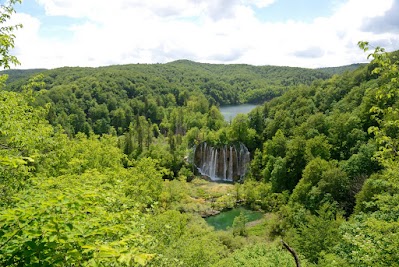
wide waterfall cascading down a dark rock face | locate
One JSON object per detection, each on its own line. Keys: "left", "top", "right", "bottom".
{"left": 194, "top": 142, "right": 250, "bottom": 182}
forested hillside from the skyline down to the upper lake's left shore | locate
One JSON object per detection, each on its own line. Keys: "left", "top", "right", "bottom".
{"left": 2, "top": 60, "right": 340, "bottom": 135}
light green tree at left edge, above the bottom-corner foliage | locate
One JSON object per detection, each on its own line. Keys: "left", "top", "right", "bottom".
{"left": 0, "top": 81, "right": 53, "bottom": 205}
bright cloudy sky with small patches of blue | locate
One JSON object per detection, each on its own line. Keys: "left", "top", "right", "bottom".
{"left": 5, "top": 0, "right": 399, "bottom": 69}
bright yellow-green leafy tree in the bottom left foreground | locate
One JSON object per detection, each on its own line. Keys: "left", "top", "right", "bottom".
{"left": 0, "top": 169, "right": 154, "bottom": 266}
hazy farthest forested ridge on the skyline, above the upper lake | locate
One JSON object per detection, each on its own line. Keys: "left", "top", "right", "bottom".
{"left": 4, "top": 60, "right": 331, "bottom": 105}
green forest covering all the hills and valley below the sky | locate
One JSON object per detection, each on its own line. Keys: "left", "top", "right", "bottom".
{"left": 0, "top": 1, "right": 399, "bottom": 267}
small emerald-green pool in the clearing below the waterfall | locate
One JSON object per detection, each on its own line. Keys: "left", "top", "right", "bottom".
{"left": 205, "top": 207, "right": 263, "bottom": 230}
